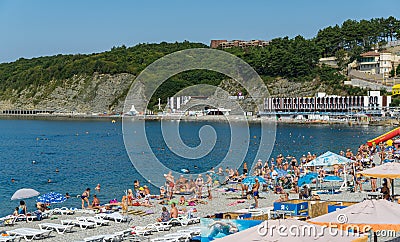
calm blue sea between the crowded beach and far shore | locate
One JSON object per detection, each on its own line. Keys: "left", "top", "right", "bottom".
{"left": 0, "top": 120, "right": 391, "bottom": 216}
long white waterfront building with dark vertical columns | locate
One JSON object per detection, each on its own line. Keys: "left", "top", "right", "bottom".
{"left": 261, "top": 91, "right": 391, "bottom": 116}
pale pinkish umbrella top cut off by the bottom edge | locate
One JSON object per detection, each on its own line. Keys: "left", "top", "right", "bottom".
{"left": 215, "top": 219, "right": 368, "bottom": 242}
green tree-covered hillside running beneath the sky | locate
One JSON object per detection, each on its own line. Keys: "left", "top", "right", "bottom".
{"left": 0, "top": 17, "right": 400, "bottom": 110}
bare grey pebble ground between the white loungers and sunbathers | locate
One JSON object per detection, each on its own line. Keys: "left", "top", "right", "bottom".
{"left": 1, "top": 184, "right": 397, "bottom": 242}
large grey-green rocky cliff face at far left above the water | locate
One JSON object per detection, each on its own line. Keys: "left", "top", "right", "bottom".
{"left": 0, "top": 74, "right": 135, "bottom": 113}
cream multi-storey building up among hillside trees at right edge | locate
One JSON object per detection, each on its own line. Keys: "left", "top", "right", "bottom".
{"left": 356, "top": 51, "right": 400, "bottom": 78}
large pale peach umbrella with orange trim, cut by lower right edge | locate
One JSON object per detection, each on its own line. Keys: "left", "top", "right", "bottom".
{"left": 309, "top": 199, "right": 400, "bottom": 232}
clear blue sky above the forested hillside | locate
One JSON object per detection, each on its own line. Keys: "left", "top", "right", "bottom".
{"left": 0, "top": 0, "right": 400, "bottom": 63}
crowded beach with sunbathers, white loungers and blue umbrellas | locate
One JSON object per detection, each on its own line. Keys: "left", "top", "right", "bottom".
{"left": 0, "top": 135, "right": 400, "bottom": 241}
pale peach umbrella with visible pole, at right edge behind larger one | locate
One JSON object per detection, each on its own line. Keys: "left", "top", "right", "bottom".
{"left": 359, "top": 162, "right": 400, "bottom": 199}
